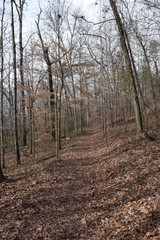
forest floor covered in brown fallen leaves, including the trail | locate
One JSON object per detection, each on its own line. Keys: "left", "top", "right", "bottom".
{"left": 0, "top": 117, "right": 160, "bottom": 240}
